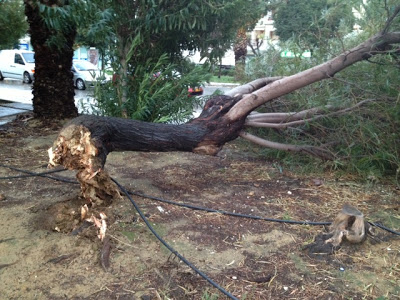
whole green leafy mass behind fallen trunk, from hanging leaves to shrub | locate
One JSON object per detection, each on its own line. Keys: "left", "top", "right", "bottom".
{"left": 87, "top": 0, "right": 263, "bottom": 122}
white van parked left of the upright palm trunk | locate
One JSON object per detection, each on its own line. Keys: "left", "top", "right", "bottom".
{"left": 0, "top": 50, "right": 35, "bottom": 83}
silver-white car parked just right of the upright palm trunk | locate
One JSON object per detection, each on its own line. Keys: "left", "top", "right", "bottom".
{"left": 71, "top": 60, "right": 110, "bottom": 90}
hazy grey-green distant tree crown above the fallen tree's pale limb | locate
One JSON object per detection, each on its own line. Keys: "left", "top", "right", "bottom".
{"left": 274, "top": 0, "right": 359, "bottom": 48}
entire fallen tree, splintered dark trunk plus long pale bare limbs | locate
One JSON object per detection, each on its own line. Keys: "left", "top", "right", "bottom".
{"left": 49, "top": 6, "right": 400, "bottom": 203}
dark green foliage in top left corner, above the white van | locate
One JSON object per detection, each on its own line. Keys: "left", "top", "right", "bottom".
{"left": 0, "top": 0, "right": 28, "bottom": 50}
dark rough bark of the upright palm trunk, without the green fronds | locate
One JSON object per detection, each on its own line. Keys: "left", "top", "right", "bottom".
{"left": 24, "top": 0, "right": 78, "bottom": 120}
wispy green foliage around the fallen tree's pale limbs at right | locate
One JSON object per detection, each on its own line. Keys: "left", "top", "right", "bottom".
{"left": 247, "top": 1, "right": 400, "bottom": 180}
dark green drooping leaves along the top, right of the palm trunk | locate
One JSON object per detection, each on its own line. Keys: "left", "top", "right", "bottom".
{"left": 77, "top": 0, "right": 265, "bottom": 63}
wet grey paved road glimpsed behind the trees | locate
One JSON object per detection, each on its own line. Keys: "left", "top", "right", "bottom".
{"left": 0, "top": 79, "right": 236, "bottom": 125}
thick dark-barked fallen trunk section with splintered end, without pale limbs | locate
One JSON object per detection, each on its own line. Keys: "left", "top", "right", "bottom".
{"left": 49, "top": 96, "right": 246, "bottom": 204}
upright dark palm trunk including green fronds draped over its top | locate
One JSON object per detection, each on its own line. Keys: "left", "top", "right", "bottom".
{"left": 24, "top": 0, "right": 78, "bottom": 119}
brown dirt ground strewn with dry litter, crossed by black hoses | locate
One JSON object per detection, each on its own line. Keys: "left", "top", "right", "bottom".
{"left": 0, "top": 116, "right": 400, "bottom": 300}
